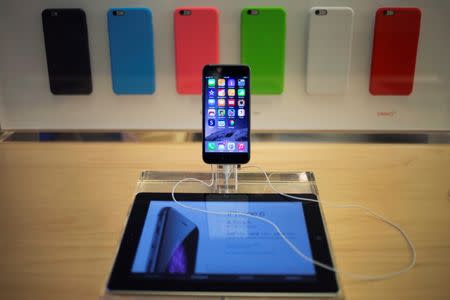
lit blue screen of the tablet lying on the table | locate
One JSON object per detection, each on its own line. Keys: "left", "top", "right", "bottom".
{"left": 132, "top": 201, "right": 315, "bottom": 280}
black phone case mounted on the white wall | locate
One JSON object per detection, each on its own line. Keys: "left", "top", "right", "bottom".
{"left": 42, "top": 9, "right": 92, "bottom": 95}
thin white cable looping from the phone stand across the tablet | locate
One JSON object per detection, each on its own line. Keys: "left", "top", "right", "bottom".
{"left": 172, "top": 165, "right": 416, "bottom": 280}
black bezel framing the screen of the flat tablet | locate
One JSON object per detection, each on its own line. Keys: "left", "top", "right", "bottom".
{"left": 107, "top": 193, "right": 339, "bottom": 295}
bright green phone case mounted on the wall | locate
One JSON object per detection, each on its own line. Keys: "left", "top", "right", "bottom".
{"left": 241, "top": 7, "right": 286, "bottom": 94}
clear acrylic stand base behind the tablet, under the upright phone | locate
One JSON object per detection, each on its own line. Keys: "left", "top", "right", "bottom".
{"left": 100, "top": 170, "right": 342, "bottom": 300}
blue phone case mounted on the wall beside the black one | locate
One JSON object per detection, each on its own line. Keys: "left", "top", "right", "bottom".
{"left": 108, "top": 8, "right": 155, "bottom": 94}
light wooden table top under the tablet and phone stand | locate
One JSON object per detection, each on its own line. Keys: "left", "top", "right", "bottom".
{"left": 0, "top": 143, "right": 450, "bottom": 300}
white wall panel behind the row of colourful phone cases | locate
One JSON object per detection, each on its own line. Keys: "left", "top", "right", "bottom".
{"left": 0, "top": 0, "right": 450, "bottom": 131}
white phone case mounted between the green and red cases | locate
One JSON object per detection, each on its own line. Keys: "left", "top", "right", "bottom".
{"left": 306, "top": 7, "right": 354, "bottom": 95}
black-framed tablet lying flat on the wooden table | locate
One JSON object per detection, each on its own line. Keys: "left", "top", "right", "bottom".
{"left": 107, "top": 193, "right": 338, "bottom": 297}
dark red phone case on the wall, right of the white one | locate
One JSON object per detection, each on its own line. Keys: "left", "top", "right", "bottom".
{"left": 369, "top": 7, "right": 421, "bottom": 95}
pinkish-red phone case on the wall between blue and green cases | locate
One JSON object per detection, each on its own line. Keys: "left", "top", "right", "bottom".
{"left": 173, "top": 7, "right": 219, "bottom": 94}
